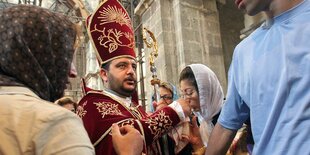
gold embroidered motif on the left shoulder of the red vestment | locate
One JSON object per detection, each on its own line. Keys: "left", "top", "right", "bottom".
{"left": 94, "top": 102, "right": 122, "bottom": 118}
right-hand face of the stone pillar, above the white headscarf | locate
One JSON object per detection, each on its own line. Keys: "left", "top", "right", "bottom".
{"left": 173, "top": 0, "right": 226, "bottom": 91}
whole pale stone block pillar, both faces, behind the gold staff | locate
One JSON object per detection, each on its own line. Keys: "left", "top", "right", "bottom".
{"left": 135, "top": 0, "right": 227, "bottom": 109}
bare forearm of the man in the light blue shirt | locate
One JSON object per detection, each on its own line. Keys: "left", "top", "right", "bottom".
{"left": 206, "top": 123, "right": 237, "bottom": 155}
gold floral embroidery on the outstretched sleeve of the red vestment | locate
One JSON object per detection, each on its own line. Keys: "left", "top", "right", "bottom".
{"left": 146, "top": 111, "right": 172, "bottom": 139}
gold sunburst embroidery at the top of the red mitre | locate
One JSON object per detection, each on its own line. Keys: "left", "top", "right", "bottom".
{"left": 98, "top": 5, "right": 131, "bottom": 27}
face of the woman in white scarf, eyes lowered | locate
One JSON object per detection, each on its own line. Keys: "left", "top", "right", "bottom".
{"left": 180, "top": 80, "right": 200, "bottom": 111}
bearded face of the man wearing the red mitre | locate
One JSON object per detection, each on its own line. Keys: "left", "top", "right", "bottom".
{"left": 101, "top": 58, "right": 137, "bottom": 96}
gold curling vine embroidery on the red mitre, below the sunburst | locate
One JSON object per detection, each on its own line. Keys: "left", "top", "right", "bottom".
{"left": 91, "top": 24, "right": 134, "bottom": 53}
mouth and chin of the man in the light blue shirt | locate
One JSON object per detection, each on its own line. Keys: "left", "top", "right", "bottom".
{"left": 235, "top": 0, "right": 272, "bottom": 16}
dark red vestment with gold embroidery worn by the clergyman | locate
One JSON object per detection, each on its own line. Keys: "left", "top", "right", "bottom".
{"left": 77, "top": 91, "right": 180, "bottom": 155}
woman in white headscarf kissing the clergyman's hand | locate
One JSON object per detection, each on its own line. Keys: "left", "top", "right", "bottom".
{"left": 173, "top": 64, "right": 224, "bottom": 154}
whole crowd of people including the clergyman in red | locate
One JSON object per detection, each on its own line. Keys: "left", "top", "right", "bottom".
{"left": 0, "top": 0, "right": 310, "bottom": 155}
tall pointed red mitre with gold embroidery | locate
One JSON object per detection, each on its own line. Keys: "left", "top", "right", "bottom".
{"left": 87, "top": 0, "right": 136, "bottom": 65}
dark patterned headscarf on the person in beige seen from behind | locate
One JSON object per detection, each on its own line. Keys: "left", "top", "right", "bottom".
{"left": 0, "top": 5, "right": 76, "bottom": 101}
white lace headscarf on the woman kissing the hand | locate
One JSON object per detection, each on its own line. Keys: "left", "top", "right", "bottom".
{"left": 189, "top": 64, "right": 224, "bottom": 146}
